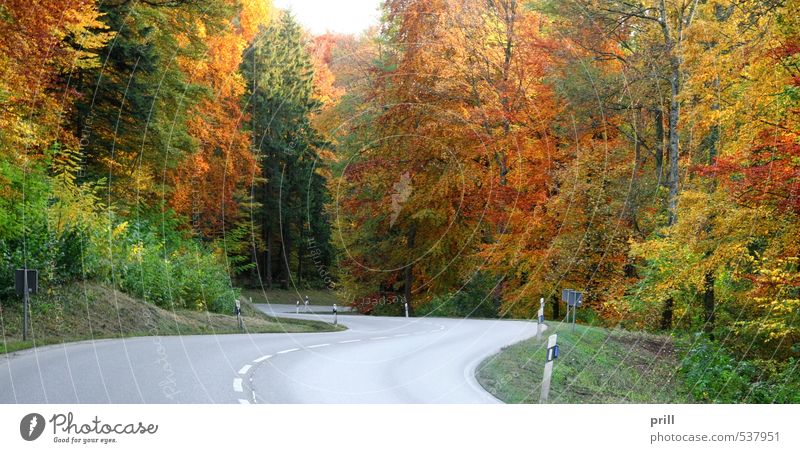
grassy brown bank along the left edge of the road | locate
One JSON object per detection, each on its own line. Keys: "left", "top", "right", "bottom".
{"left": 0, "top": 283, "right": 343, "bottom": 353}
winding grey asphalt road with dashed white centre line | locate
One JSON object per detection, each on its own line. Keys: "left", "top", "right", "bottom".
{"left": 0, "top": 305, "right": 536, "bottom": 404}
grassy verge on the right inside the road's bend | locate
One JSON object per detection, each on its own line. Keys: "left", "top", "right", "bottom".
{"left": 477, "top": 323, "right": 690, "bottom": 403}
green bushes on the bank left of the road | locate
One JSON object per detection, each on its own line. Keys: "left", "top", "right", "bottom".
{"left": 0, "top": 151, "right": 238, "bottom": 313}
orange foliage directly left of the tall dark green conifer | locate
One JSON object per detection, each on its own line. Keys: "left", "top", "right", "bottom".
{"left": 171, "top": 0, "right": 271, "bottom": 237}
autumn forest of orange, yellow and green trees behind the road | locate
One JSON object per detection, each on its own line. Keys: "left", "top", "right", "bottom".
{"left": 0, "top": 0, "right": 800, "bottom": 402}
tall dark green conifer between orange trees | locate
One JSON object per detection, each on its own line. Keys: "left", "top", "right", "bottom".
{"left": 241, "top": 13, "right": 333, "bottom": 289}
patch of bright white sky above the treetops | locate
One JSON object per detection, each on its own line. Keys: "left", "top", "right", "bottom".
{"left": 273, "top": 0, "right": 380, "bottom": 35}
